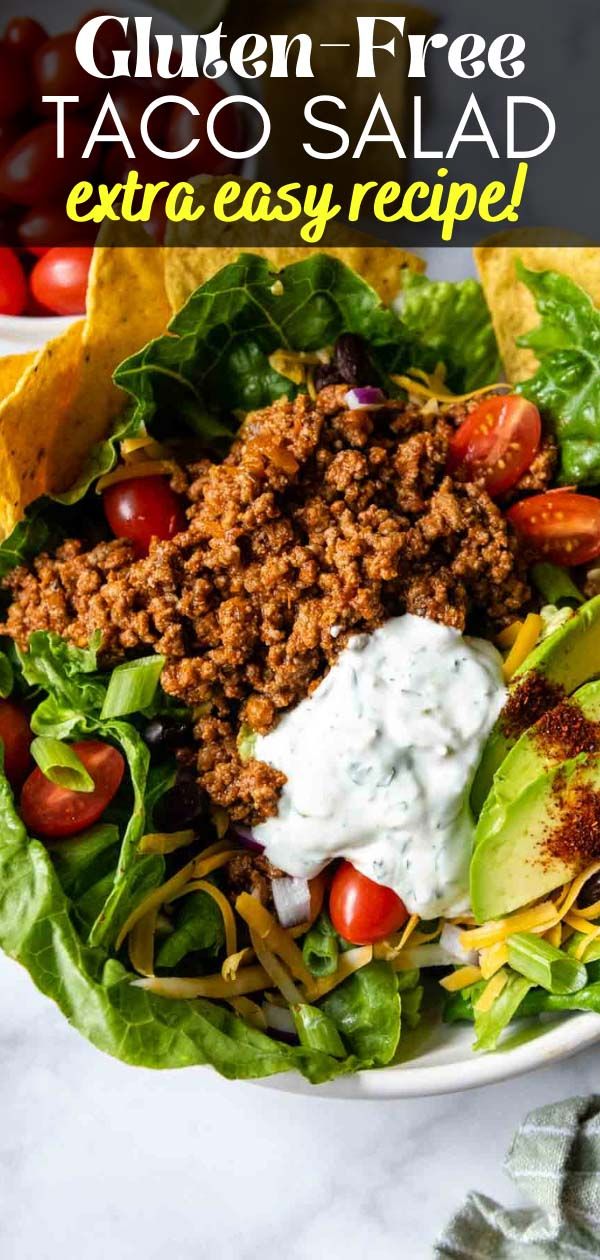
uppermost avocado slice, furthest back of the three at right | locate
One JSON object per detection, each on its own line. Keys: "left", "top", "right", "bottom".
{"left": 470, "top": 595, "right": 600, "bottom": 818}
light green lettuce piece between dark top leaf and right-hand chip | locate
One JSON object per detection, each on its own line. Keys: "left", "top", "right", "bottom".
{"left": 401, "top": 272, "right": 502, "bottom": 394}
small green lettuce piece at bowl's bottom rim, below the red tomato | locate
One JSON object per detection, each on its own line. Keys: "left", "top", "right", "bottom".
{"left": 320, "top": 961, "right": 401, "bottom": 1067}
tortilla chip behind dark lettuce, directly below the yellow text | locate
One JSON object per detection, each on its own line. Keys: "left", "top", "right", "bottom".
{"left": 165, "top": 176, "right": 425, "bottom": 311}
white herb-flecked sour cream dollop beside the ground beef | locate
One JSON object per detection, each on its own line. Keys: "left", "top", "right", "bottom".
{"left": 255, "top": 614, "right": 505, "bottom": 919}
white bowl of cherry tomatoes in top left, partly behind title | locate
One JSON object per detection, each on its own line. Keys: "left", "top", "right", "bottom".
{"left": 0, "top": 0, "right": 250, "bottom": 355}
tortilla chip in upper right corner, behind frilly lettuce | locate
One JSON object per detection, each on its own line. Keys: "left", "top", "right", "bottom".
{"left": 474, "top": 244, "right": 600, "bottom": 384}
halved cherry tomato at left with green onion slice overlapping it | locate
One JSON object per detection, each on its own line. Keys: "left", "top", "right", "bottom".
{"left": 20, "top": 740, "right": 125, "bottom": 839}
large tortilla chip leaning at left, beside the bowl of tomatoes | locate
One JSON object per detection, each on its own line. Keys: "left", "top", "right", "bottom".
{"left": 0, "top": 224, "right": 170, "bottom": 537}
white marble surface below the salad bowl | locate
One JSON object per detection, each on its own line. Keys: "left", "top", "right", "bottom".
{"left": 0, "top": 956, "right": 597, "bottom": 1260}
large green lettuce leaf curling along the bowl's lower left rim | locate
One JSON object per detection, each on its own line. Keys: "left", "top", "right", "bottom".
{"left": 0, "top": 756, "right": 355, "bottom": 1082}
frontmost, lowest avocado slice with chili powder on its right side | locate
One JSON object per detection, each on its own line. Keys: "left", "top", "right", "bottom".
{"left": 470, "top": 753, "right": 600, "bottom": 922}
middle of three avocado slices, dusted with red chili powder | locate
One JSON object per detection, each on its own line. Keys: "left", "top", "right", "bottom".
{"left": 475, "top": 682, "right": 600, "bottom": 844}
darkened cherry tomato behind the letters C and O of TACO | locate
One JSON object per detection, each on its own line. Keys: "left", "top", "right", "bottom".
{"left": 165, "top": 78, "right": 242, "bottom": 175}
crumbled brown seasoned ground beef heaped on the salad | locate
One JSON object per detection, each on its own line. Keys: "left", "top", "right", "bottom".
{"left": 4, "top": 386, "right": 529, "bottom": 822}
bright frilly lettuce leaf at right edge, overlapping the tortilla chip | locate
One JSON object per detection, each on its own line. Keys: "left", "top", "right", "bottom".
{"left": 516, "top": 261, "right": 600, "bottom": 485}
